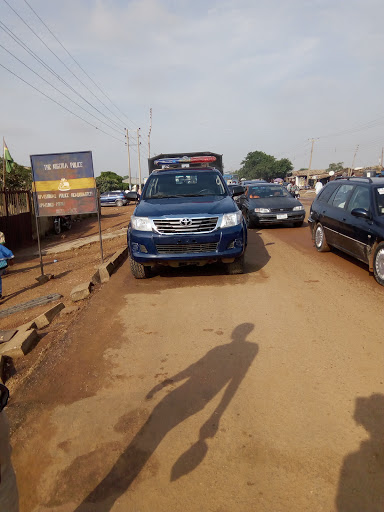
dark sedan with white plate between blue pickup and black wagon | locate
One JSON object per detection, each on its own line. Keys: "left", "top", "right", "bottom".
{"left": 238, "top": 183, "right": 305, "bottom": 228}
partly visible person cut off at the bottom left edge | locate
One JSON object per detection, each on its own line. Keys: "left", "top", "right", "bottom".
{"left": 0, "top": 384, "right": 19, "bottom": 512}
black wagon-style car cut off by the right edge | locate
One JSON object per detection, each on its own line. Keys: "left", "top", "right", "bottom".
{"left": 308, "top": 177, "right": 384, "bottom": 286}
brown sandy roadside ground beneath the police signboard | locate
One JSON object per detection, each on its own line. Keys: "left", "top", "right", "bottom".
{"left": 0, "top": 205, "right": 134, "bottom": 329}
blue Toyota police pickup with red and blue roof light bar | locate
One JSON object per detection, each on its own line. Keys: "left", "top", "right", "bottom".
{"left": 128, "top": 157, "right": 247, "bottom": 279}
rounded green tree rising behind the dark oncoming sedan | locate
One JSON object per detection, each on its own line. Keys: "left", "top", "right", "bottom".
{"left": 238, "top": 151, "right": 293, "bottom": 181}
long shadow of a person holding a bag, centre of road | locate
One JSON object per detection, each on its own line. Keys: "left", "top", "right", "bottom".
{"left": 75, "top": 323, "right": 258, "bottom": 512}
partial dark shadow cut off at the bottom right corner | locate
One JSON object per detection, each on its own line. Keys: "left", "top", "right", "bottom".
{"left": 336, "top": 394, "right": 384, "bottom": 512}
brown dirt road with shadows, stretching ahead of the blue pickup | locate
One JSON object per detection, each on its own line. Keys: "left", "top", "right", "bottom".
{"left": 9, "top": 216, "right": 384, "bottom": 512}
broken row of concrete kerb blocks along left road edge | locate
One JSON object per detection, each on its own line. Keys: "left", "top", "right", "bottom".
{"left": 0, "top": 247, "right": 128, "bottom": 383}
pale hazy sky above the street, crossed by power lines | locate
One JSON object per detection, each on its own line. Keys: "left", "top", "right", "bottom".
{"left": 0, "top": 0, "right": 384, "bottom": 180}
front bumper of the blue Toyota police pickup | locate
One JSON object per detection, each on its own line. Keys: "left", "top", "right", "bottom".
{"left": 128, "top": 223, "right": 247, "bottom": 266}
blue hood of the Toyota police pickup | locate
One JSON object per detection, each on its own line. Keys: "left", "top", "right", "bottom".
{"left": 134, "top": 196, "right": 238, "bottom": 217}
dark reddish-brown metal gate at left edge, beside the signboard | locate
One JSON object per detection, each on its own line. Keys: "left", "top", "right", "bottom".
{"left": 0, "top": 190, "right": 32, "bottom": 250}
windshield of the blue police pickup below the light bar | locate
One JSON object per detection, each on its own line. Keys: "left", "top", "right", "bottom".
{"left": 144, "top": 170, "right": 227, "bottom": 199}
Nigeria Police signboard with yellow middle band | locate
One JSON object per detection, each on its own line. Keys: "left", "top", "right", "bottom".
{"left": 31, "top": 151, "right": 98, "bottom": 217}
